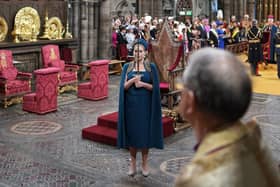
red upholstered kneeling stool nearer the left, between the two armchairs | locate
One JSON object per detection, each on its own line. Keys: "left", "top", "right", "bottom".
{"left": 22, "top": 67, "right": 59, "bottom": 114}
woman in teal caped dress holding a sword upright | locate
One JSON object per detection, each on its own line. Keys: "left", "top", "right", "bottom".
{"left": 118, "top": 39, "right": 163, "bottom": 176}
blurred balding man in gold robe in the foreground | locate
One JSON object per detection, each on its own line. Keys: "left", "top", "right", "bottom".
{"left": 175, "top": 48, "right": 280, "bottom": 187}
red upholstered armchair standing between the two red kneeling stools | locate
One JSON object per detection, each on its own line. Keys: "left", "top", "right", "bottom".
{"left": 42, "top": 45, "right": 79, "bottom": 93}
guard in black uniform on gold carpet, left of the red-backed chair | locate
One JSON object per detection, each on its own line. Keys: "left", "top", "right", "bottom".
{"left": 247, "top": 19, "right": 263, "bottom": 76}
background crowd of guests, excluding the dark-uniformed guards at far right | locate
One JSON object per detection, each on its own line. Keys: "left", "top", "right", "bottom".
{"left": 112, "top": 14, "right": 250, "bottom": 58}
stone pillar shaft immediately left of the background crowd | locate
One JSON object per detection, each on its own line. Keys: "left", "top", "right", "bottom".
{"left": 98, "top": 0, "right": 112, "bottom": 58}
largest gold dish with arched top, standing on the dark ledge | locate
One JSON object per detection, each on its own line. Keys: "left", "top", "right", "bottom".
{"left": 12, "top": 7, "right": 40, "bottom": 42}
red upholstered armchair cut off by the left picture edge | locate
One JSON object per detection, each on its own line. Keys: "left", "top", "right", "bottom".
{"left": 0, "top": 50, "right": 32, "bottom": 108}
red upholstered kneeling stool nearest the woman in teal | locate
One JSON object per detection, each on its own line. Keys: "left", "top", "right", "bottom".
{"left": 78, "top": 60, "right": 109, "bottom": 100}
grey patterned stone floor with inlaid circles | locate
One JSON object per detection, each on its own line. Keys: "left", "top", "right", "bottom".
{"left": 0, "top": 75, "right": 280, "bottom": 187}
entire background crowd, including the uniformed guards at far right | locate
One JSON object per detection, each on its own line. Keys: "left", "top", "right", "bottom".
{"left": 112, "top": 14, "right": 280, "bottom": 78}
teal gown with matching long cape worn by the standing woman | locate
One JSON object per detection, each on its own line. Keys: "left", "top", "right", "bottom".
{"left": 118, "top": 64, "right": 163, "bottom": 149}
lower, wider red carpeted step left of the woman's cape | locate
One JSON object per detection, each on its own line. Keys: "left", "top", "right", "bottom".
{"left": 82, "top": 125, "right": 117, "bottom": 146}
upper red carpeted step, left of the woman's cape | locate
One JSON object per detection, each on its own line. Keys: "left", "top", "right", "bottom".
{"left": 97, "top": 112, "right": 118, "bottom": 129}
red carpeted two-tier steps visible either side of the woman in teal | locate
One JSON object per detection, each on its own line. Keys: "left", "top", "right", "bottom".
{"left": 82, "top": 112, "right": 174, "bottom": 146}
